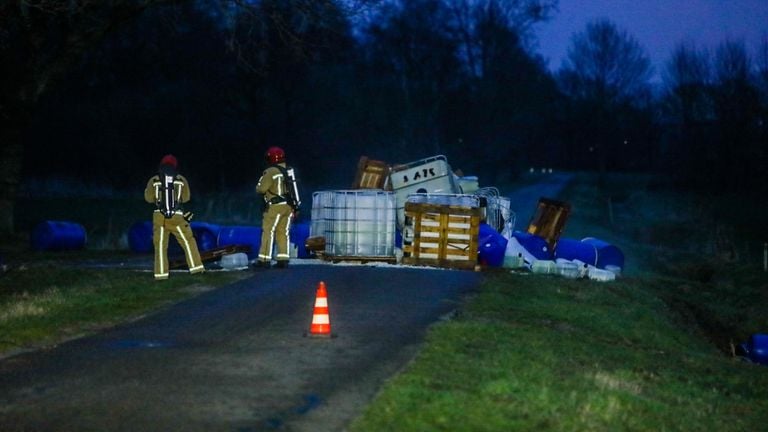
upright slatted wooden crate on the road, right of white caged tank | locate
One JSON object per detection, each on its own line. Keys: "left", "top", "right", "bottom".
{"left": 403, "top": 202, "right": 482, "bottom": 269}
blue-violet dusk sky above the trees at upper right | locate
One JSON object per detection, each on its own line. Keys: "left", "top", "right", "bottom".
{"left": 537, "top": 0, "right": 768, "bottom": 81}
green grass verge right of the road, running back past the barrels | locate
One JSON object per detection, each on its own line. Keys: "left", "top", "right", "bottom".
{"left": 350, "top": 175, "right": 768, "bottom": 431}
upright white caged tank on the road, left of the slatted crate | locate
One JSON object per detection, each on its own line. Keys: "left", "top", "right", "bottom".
{"left": 310, "top": 189, "right": 396, "bottom": 257}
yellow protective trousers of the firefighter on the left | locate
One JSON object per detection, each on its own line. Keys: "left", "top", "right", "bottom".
{"left": 152, "top": 211, "right": 205, "bottom": 279}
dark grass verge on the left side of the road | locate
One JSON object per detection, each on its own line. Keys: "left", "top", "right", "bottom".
{"left": 0, "top": 253, "right": 243, "bottom": 355}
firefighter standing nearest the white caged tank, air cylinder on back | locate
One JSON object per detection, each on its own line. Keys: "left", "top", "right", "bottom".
{"left": 255, "top": 147, "right": 297, "bottom": 269}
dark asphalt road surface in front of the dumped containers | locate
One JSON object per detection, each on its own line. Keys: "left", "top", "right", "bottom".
{"left": 0, "top": 265, "right": 482, "bottom": 432}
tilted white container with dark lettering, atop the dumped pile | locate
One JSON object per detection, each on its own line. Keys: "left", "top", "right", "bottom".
{"left": 390, "top": 155, "right": 460, "bottom": 227}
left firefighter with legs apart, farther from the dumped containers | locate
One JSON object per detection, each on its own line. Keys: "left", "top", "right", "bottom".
{"left": 144, "top": 154, "right": 205, "bottom": 280}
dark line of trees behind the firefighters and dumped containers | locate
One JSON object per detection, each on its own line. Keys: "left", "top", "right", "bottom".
{"left": 9, "top": 0, "right": 768, "bottom": 198}
